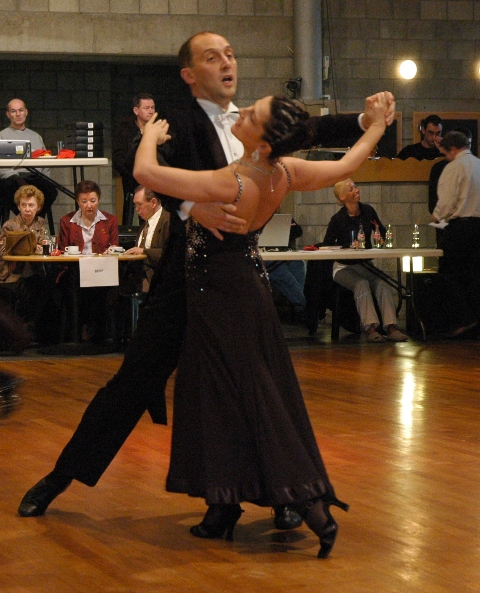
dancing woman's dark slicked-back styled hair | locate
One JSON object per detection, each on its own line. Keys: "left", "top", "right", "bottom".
{"left": 262, "top": 95, "right": 311, "bottom": 160}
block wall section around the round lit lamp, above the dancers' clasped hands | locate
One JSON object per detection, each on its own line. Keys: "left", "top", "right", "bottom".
{"left": 324, "top": 0, "right": 480, "bottom": 145}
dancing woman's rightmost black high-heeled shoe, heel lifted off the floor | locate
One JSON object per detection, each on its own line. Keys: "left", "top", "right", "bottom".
{"left": 297, "top": 497, "right": 349, "bottom": 558}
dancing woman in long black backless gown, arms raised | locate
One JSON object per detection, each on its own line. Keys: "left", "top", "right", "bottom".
{"left": 134, "top": 93, "right": 389, "bottom": 558}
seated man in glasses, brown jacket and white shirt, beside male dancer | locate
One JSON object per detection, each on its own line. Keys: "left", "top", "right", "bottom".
{"left": 126, "top": 185, "right": 170, "bottom": 292}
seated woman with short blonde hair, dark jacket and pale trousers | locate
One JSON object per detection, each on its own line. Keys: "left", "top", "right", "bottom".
{"left": 323, "top": 179, "right": 407, "bottom": 342}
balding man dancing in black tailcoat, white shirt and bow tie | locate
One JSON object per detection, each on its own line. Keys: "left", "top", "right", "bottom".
{"left": 18, "top": 32, "right": 394, "bottom": 528}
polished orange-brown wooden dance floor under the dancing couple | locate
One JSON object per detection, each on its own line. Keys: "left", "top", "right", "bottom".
{"left": 0, "top": 328, "right": 480, "bottom": 593}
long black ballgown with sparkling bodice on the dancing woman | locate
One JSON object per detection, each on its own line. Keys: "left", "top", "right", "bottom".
{"left": 167, "top": 220, "right": 334, "bottom": 506}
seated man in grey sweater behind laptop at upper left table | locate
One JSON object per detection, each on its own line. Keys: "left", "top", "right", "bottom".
{"left": 0, "top": 99, "right": 58, "bottom": 223}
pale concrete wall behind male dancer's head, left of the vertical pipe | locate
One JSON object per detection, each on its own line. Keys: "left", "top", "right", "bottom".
{"left": 0, "top": 0, "right": 293, "bottom": 104}
